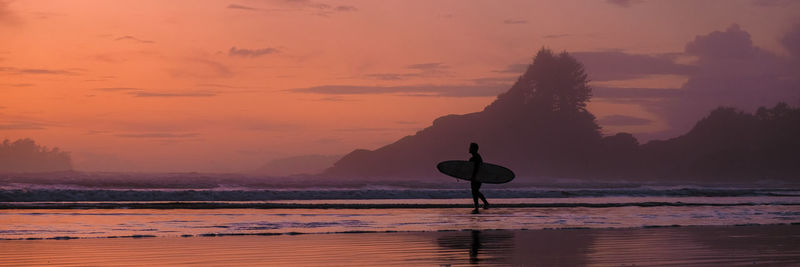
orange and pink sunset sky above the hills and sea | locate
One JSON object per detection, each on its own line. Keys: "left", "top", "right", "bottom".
{"left": 0, "top": 0, "right": 800, "bottom": 172}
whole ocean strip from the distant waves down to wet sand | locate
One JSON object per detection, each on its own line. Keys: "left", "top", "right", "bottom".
{"left": 0, "top": 181, "right": 800, "bottom": 240}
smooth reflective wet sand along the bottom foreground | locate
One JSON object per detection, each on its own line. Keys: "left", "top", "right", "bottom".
{"left": 0, "top": 225, "right": 800, "bottom": 266}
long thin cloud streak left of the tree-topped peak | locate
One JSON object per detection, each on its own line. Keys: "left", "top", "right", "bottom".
{"left": 289, "top": 85, "right": 507, "bottom": 97}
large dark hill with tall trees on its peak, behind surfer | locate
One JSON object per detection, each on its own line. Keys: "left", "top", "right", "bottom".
{"left": 323, "top": 49, "right": 602, "bottom": 181}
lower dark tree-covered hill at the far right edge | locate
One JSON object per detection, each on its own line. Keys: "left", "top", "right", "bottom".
{"left": 631, "top": 103, "right": 800, "bottom": 181}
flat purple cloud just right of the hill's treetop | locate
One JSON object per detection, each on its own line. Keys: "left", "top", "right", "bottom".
{"left": 570, "top": 51, "right": 694, "bottom": 81}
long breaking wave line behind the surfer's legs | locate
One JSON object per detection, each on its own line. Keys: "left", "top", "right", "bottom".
{"left": 0, "top": 188, "right": 800, "bottom": 202}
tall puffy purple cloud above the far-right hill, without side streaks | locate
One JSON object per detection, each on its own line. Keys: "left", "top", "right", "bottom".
{"left": 651, "top": 24, "right": 800, "bottom": 129}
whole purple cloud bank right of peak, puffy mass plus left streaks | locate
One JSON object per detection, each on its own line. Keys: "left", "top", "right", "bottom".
{"left": 596, "top": 24, "right": 800, "bottom": 138}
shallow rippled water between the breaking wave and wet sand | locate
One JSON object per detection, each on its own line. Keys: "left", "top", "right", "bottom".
{"left": 0, "top": 197, "right": 800, "bottom": 239}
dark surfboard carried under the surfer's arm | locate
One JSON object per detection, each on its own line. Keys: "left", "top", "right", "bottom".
{"left": 436, "top": 160, "right": 514, "bottom": 184}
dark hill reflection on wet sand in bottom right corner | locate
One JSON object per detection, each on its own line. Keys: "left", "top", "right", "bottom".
{"left": 588, "top": 225, "right": 800, "bottom": 266}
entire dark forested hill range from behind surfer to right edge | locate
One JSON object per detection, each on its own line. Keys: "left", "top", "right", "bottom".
{"left": 323, "top": 49, "right": 800, "bottom": 181}
